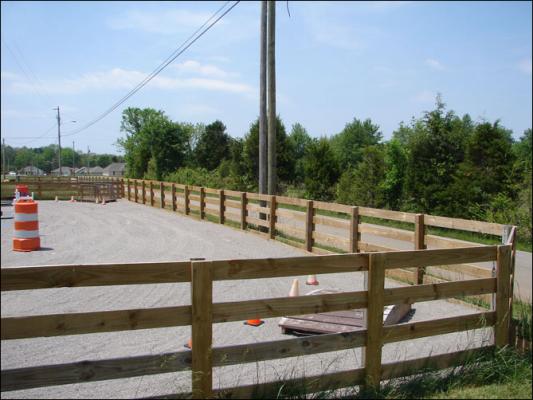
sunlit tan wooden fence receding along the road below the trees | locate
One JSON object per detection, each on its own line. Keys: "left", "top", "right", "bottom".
{"left": 122, "top": 179, "right": 516, "bottom": 304}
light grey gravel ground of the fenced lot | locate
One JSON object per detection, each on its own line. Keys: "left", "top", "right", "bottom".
{"left": 1, "top": 201, "right": 492, "bottom": 398}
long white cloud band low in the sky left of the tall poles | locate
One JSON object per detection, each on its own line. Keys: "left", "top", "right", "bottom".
{"left": 3, "top": 68, "right": 255, "bottom": 96}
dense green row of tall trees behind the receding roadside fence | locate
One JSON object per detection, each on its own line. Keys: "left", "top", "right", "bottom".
{"left": 119, "top": 98, "right": 532, "bottom": 241}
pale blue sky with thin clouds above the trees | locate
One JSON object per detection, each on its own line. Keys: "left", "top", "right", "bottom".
{"left": 0, "top": 1, "right": 532, "bottom": 154}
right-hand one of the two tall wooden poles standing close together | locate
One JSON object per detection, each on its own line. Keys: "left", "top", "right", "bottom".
{"left": 267, "top": 0, "right": 277, "bottom": 194}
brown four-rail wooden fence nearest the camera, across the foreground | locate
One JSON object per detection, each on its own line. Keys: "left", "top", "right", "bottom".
{"left": 1, "top": 244, "right": 512, "bottom": 398}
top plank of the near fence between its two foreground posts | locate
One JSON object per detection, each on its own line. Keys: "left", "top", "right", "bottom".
{"left": 213, "top": 254, "right": 369, "bottom": 280}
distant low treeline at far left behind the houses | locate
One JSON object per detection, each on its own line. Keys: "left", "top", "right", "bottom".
{"left": 1, "top": 144, "right": 124, "bottom": 174}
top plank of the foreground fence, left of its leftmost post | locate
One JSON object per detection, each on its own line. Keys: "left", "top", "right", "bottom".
{"left": 0, "top": 262, "right": 191, "bottom": 291}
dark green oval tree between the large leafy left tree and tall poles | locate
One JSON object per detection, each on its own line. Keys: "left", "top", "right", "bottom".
{"left": 194, "top": 120, "right": 230, "bottom": 171}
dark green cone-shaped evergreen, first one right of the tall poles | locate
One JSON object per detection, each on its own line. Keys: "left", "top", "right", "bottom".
{"left": 303, "top": 138, "right": 339, "bottom": 200}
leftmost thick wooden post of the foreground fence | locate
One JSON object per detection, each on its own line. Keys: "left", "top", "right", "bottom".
{"left": 191, "top": 261, "right": 213, "bottom": 399}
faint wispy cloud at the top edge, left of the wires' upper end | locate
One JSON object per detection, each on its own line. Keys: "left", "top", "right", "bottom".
{"left": 107, "top": 10, "right": 219, "bottom": 35}
